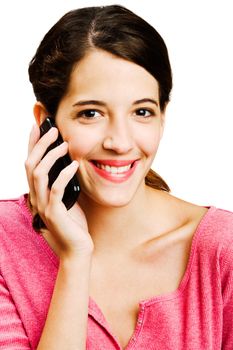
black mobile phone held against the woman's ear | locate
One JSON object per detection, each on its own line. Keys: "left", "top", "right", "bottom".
{"left": 33, "top": 117, "right": 80, "bottom": 230}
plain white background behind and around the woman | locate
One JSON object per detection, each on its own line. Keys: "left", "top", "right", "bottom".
{"left": 0, "top": 0, "right": 233, "bottom": 211}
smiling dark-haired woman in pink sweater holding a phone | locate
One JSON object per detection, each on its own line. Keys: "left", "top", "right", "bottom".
{"left": 0, "top": 6, "right": 233, "bottom": 350}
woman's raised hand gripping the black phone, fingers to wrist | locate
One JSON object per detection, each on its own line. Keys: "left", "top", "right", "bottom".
{"left": 25, "top": 125, "right": 94, "bottom": 259}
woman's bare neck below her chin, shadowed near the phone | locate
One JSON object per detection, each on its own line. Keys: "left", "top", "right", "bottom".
{"left": 80, "top": 186, "right": 164, "bottom": 254}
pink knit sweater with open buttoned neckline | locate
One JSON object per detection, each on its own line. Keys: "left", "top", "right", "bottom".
{"left": 0, "top": 195, "right": 233, "bottom": 350}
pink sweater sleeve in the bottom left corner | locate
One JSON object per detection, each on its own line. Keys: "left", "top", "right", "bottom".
{"left": 0, "top": 275, "right": 31, "bottom": 350}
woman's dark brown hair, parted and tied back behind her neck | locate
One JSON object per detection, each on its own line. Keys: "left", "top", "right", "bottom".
{"left": 29, "top": 5, "right": 172, "bottom": 192}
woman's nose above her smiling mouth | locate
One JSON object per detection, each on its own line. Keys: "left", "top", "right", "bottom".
{"left": 103, "top": 121, "right": 133, "bottom": 154}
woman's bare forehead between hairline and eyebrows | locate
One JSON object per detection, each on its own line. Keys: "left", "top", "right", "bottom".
{"left": 69, "top": 50, "right": 158, "bottom": 99}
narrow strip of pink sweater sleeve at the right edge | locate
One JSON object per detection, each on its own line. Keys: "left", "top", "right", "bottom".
{"left": 222, "top": 243, "right": 233, "bottom": 350}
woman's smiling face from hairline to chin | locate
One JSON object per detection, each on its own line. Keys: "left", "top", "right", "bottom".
{"left": 56, "top": 50, "right": 164, "bottom": 207}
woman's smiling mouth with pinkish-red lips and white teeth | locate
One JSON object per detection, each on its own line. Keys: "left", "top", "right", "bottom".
{"left": 90, "top": 159, "right": 139, "bottom": 183}
